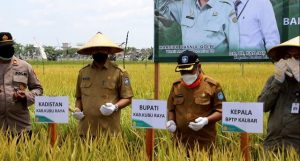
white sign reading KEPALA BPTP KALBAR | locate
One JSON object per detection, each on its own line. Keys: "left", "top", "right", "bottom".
{"left": 222, "top": 102, "right": 263, "bottom": 133}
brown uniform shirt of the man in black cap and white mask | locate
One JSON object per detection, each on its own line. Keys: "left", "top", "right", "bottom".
{"left": 168, "top": 76, "right": 225, "bottom": 147}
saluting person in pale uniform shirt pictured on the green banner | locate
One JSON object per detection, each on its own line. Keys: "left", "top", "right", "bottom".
{"left": 160, "top": 0, "right": 239, "bottom": 54}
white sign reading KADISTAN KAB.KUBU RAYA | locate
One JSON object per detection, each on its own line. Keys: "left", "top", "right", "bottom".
{"left": 35, "top": 96, "right": 69, "bottom": 123}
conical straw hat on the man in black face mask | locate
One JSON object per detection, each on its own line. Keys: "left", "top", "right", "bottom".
{"left": 77, "top": 32, "right": 123, "bottom": 55}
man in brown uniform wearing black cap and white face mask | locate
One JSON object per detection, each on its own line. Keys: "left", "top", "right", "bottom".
{"left": 167, "top": 51, "right": 225, "bottom": 150}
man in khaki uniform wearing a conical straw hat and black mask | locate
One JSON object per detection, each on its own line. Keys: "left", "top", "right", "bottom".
{"left": 73, "top": 33, "right": 133, "bottom": 137}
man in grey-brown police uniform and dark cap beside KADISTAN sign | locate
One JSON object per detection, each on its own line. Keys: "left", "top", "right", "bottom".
{"left": 0, "top": 32, "right": 43, "bottom": 135}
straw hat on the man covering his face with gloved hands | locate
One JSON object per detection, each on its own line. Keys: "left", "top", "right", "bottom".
{"left": 267, "top": 36, "right": 300, "bottom": 61}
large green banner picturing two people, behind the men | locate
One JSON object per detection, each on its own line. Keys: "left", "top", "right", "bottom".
{"left": 154, "top": 0, "right": 300, "bottom": 62}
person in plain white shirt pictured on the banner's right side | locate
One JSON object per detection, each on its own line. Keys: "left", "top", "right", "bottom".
{"left": 235, "top": 0, "right": 280, "bottom": 51}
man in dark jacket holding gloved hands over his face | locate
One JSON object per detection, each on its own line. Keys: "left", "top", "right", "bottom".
{"left": 258, "top": 36, "right": 300, "bottom": 154}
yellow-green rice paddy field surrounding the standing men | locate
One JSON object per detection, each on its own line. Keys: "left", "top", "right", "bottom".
{"left": 0, "top": 61, "right": 300, "bottom": 161}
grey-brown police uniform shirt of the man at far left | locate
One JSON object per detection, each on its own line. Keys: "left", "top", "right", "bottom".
{"left": 0, "top": 57, "right": 43, "bottom": 133}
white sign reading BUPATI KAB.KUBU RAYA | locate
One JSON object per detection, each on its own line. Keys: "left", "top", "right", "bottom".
{"left": 132, "top": 99, "right": 167, "bottom": 129}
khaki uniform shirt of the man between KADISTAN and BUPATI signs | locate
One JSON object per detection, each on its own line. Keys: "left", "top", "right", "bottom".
{"left": 76, "top": 60, "right": 133, "bottom": 136}
